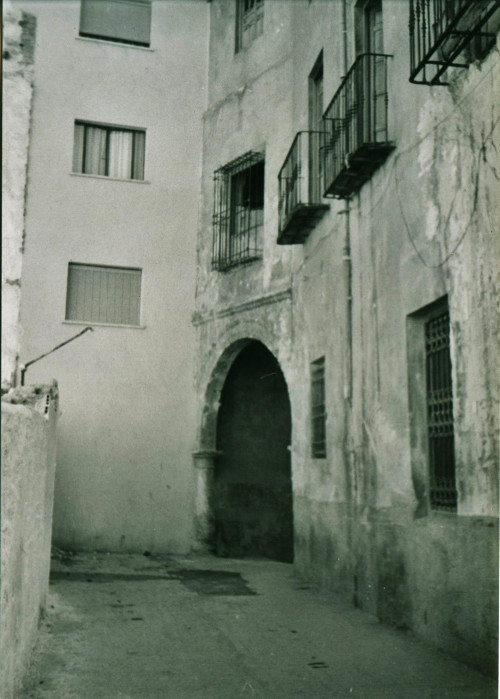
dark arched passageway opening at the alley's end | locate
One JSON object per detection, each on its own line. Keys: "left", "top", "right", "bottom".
{"left": 213, "top": 341, "right": 293, "bottom": 562}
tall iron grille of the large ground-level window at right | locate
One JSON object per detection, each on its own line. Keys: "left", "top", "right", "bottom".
{"left": 425, "top": 310, "right": 457, "bottom": 511}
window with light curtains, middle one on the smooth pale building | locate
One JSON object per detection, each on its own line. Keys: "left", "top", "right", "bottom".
{"left": 73, "top": 121, "right": 146, "bottom": 180}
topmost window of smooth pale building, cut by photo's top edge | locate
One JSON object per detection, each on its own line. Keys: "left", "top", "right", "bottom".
{"left": 80, "top": 0, "right": 151, "bottom": 46}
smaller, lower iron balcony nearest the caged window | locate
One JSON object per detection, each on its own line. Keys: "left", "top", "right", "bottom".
{"left": 278, "top": 131, "right": 329, "bottom": 245}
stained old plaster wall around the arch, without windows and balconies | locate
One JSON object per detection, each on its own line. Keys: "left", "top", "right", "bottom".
{"left": 195, "top": 0, "right": 500, "bottom": 672}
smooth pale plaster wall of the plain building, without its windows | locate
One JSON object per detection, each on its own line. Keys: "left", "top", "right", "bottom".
{"left": 18, "top": 0, "right": 208, "bottom": 552}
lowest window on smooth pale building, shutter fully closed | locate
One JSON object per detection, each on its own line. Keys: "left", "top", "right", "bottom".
{"left": 66, "top": 262, "right": 142, "bottom": 325}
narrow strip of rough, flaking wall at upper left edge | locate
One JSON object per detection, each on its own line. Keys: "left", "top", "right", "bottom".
{"left": 2, "top": 1, "right": 36, "bottom": 387}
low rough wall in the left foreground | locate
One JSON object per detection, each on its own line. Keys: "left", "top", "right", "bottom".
{"left": 0, "top": 382, "right": 58, "bottom": 699}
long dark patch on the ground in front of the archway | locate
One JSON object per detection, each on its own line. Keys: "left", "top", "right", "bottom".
{"left": 50, "top": 568, "right": 256, "bottom": 606}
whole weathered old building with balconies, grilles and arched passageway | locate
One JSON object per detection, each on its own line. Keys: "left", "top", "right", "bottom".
{"left": 194, "top": 0, "right": 499, "bottom": 670}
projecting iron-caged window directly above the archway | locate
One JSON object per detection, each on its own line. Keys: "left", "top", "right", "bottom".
{"left": 212, "top": 151, "right": 264, "bottom": 270}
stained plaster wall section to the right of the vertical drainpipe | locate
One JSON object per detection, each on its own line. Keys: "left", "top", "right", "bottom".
{"left": 342, "top": 3, "right": 499, "bottom": 672}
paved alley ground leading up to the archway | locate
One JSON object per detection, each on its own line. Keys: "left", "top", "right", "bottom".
{"left": 22, "top": 554, "right": 497, "bottom": 699}
